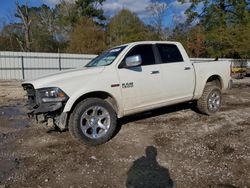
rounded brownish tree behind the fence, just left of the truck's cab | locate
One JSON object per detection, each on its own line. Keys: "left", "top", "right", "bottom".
{"left": 67, "top": 17, "right": 105, "bottom": 54}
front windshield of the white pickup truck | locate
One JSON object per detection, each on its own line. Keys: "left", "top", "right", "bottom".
{"left": 85, "top": 46, "right": 126, "bottom": 67}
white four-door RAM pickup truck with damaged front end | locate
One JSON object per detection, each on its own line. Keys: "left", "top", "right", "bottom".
{"left": 22, "top": 41, "right": 231, "bottom": 145}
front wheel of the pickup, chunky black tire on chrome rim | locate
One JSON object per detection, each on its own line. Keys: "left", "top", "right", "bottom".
{"left": 69, "top": 98, "right": 117, "bottom": 146}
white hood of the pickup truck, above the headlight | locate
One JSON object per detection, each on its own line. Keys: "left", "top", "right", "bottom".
{"left": 22, "top": 67, "right": 105, "bottom": 89}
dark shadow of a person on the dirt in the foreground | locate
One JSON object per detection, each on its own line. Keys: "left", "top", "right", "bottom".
{"left": 126, "top": 146, "right": 173, "bottom": 188}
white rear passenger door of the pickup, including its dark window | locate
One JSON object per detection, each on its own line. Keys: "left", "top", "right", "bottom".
{"left": 156, "top": 44, "right": 195, "bottom": 101}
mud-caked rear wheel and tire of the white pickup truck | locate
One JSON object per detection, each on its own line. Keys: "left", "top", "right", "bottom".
{"left": 197, "top": 84, "right": 222, "bottom": 115}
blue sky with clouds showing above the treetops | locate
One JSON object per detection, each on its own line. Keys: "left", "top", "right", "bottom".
{"left": 0, "top": 0, "right": 190, "bottom": 27}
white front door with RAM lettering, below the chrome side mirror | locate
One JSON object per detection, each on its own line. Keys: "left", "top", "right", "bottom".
{"left": 118, "top": 44, "right": 162, "bottom": 114}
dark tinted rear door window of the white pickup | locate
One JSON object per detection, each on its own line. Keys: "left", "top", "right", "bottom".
{"left": 156, "top": 44, "right": 183, "bottom": 63}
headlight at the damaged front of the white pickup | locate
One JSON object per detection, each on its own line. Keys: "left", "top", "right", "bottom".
{"left": 37, "top": 87, "right": 69, "bottom": 103}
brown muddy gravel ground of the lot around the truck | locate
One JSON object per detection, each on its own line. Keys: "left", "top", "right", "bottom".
{"left": 0, "top": 78, "right": 250, "bottom": 188}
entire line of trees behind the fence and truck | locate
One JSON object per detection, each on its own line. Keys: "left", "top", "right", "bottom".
{"left": 0, "top": 0, "right": 250, "bottom": 58}
